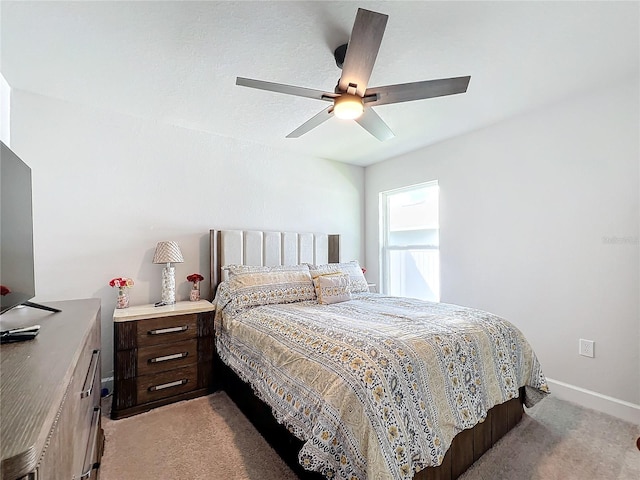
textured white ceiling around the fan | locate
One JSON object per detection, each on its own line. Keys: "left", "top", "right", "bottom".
{"left": 0, "top": 0, "right": 640, "bottom": 165}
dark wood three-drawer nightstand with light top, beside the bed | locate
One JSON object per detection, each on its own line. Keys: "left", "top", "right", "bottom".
{"left": 111, "top": 300, "right": 215, "bottom": 419}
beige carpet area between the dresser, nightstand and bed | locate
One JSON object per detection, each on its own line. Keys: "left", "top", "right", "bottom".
{"left": 100, "top": 393, "right": 297, "bottom": 480}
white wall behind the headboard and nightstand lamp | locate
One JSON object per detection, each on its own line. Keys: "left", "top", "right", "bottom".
{"left": 11, "top": 89, "right": 364, "bottom": 377}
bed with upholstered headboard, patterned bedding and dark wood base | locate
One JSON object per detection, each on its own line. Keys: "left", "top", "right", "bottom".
{"left": 210, "top": 230, "right": 548, "bottom": 480}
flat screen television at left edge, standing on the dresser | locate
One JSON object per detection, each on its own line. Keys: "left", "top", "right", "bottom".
{"left": 0, "top": 142, "right": 58, "bottom": 314}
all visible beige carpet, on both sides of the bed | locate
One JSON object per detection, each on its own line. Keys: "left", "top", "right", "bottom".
{"left": 100, "top": 393, "right": 640, "bottom": 480}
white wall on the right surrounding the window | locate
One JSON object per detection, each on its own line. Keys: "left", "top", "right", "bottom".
{"left": 365, "top": 77, "right": 640, "bottom": 423}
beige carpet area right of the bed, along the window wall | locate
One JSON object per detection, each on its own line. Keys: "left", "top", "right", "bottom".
{"left": 459, "top": 396, "right": 640, "bottom": 480}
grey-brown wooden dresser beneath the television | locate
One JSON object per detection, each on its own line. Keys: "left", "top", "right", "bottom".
{"left": 0, "top": 299, "right": 104, "bottom": 480}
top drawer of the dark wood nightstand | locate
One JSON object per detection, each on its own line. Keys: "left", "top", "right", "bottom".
{"left": 137, "top": 314, "right": 198, "bottom": 347}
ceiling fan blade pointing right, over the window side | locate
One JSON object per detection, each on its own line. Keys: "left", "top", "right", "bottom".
{"left": 364, "top": 76, "right": 471, "bottom": 106}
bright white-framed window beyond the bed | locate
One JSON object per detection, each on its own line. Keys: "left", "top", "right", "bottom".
{"left": 380, "top": 182, "right": 440, "bottom": 302}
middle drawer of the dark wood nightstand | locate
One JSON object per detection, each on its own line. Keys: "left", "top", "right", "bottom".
{"left": 138, "top": 338, "right": 198, "bottom": 375}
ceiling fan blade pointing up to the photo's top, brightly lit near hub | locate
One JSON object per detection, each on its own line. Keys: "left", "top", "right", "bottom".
{"left": 338, "top": 8, "right": 389, "bottom": 97}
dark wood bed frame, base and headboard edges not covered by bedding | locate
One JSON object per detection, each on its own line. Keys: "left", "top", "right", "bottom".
{"left": 210, "top": 230, "right": 524, "bottom": 480}
